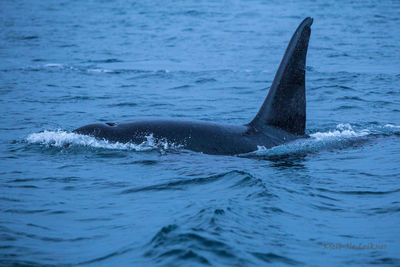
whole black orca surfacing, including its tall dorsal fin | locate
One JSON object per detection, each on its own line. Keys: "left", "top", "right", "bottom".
{"left": 73, "top": 17, "right": 313, "bottom": 155}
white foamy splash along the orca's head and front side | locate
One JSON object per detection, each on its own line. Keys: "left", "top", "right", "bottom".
{"left": 26, "top": 130, "right": 180, "bottom": 151}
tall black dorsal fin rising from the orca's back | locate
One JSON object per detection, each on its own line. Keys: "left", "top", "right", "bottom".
{"left": 249, "top": 17, "right": 313, "bottom": 135}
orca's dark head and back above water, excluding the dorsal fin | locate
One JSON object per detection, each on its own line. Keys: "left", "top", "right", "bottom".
{"left": 74, "top": 119, "right": 299, "bottom": 155}
